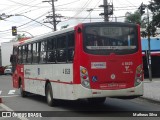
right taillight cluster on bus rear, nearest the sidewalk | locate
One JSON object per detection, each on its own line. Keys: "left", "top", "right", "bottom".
{"left": 134, "top": 65, "right": 143, "bottom": 86}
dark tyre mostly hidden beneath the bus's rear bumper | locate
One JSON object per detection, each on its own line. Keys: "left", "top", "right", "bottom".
{"left": 88, "top": 97, "right": 106, "bottom": 104}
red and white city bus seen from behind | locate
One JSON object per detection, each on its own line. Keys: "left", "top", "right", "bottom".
{"left": 11, "top": 22, "right": 143, "bottom": 106}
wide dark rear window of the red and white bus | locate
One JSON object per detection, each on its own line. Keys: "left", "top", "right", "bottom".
{"left": 84, "top": 26, "right": 138, "bottom": 55}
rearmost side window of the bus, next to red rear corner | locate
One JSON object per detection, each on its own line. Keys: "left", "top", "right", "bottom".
{"left": 67, "top": 32, "right": 75, "bottom": 62}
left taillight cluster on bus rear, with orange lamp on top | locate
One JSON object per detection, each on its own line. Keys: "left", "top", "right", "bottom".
{"left": 80, "top": 66, "right": 90, "bottom": 88}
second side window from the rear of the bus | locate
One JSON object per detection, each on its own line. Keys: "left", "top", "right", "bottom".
{"left": 57, "top": 35, "right": 67, "bottom": 62}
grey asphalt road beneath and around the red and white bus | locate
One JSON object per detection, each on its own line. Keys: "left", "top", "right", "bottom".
{"left": 0, "top": 75, "right": 160, "bottom": 120}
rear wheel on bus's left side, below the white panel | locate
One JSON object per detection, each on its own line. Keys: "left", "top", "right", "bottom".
{"left": 46, "top": 83, "right": 56, "bottom": 106}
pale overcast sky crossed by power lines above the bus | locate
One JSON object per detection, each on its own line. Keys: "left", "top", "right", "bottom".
{"left": 0, "top": 0, "right": 151, "bottom": 44}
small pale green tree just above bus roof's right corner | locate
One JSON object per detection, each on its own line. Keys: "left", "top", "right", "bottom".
{"left": 125, "top": 11, "right": 145, "bottom": 28}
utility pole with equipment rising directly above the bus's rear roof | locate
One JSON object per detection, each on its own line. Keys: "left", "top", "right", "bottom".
{"left": 99, "top": 0, "right": 113, "bottom": 22}
